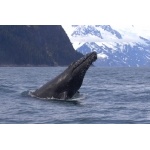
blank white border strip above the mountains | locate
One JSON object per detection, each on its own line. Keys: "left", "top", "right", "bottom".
{"left": 0, "top": 0, "right": 150, "bottom": 27}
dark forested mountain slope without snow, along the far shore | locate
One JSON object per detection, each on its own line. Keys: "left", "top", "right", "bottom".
{"left": 0, "top": 25, "right": 82, "bottom": 66}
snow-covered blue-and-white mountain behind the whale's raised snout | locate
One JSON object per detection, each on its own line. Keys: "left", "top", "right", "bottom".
{"left": 63, "top": 25, "right": 150, "bottom": 67}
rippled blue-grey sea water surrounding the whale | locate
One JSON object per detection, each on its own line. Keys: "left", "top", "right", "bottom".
{"left": 0, "top": 67, "right": 150, "bottom": 124}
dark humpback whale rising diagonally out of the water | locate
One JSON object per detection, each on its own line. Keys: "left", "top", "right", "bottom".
{"left": 32, "top": 52, "right": 97, "bottom": 100}
